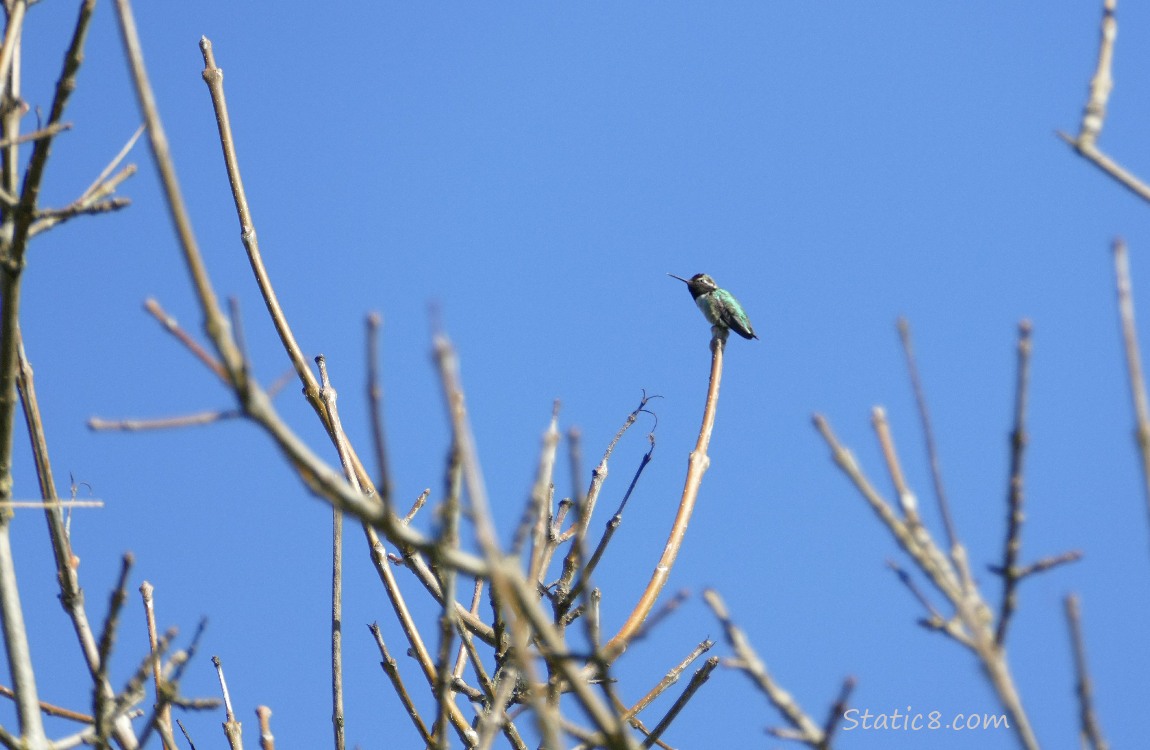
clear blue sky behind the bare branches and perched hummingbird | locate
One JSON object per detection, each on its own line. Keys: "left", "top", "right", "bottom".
{"left": 0, "top": 1, "right": 1150, "bottom": 749}
